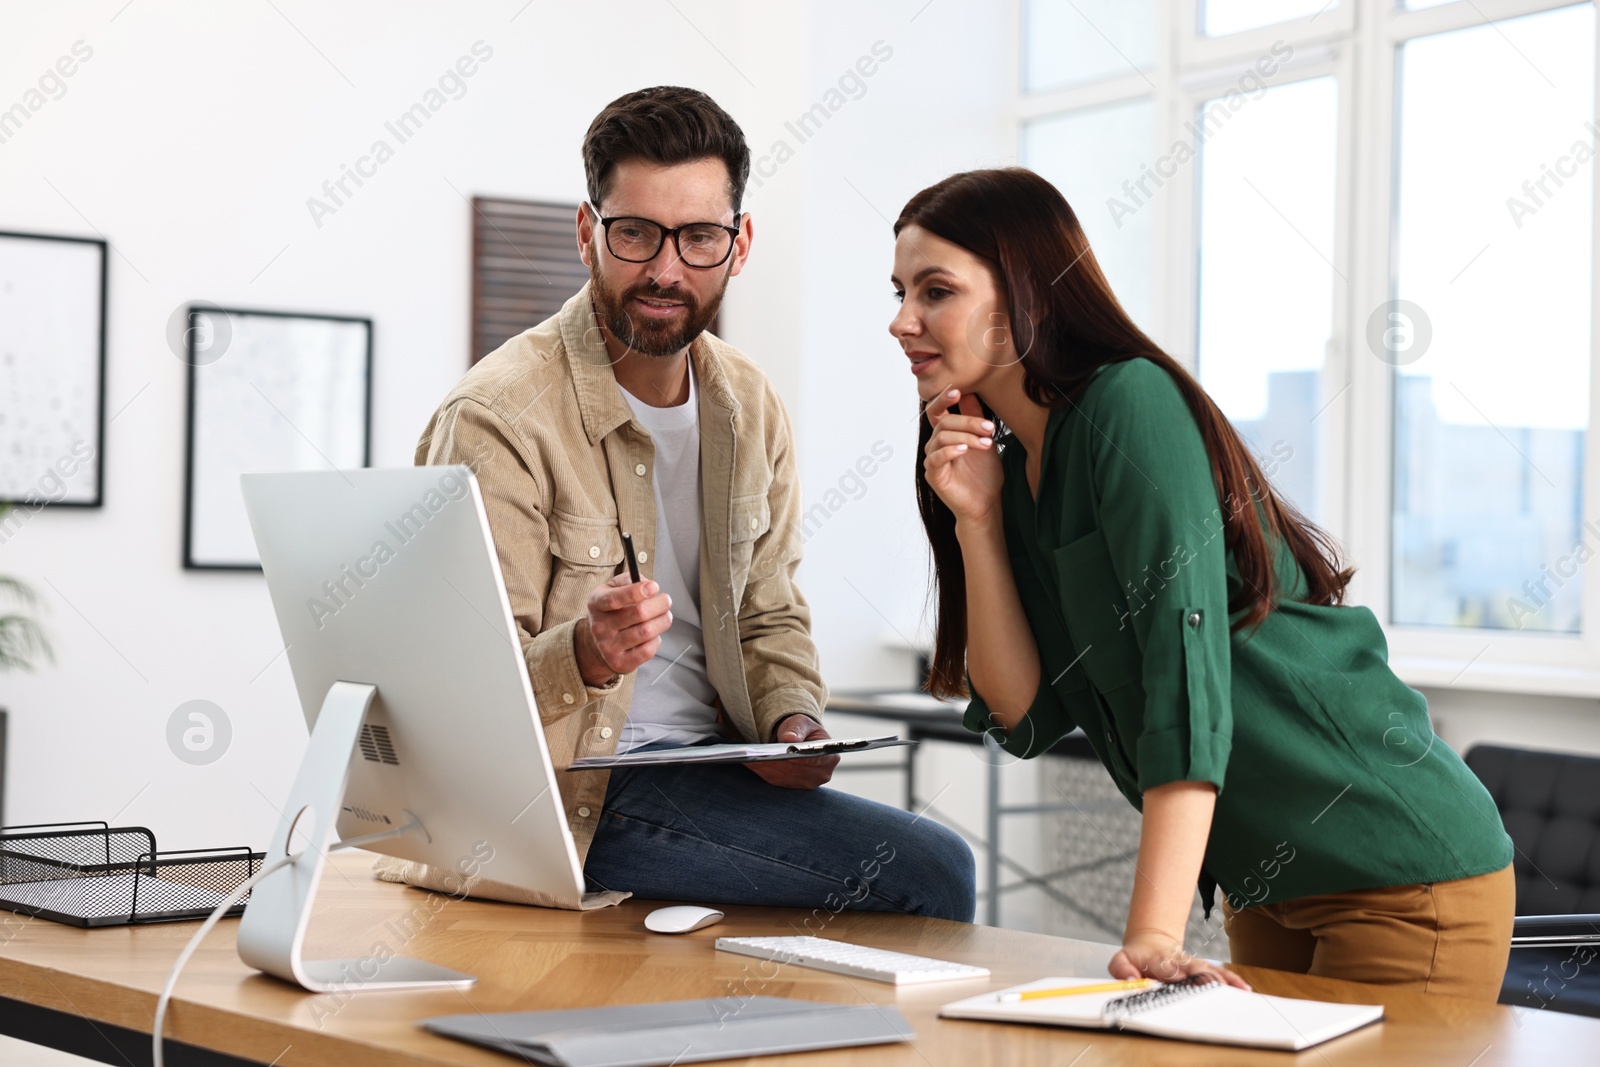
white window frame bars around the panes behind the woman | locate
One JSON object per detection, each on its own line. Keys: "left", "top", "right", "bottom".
{"left": 1011, "top": 0, "right": 1600, "bottom": 696}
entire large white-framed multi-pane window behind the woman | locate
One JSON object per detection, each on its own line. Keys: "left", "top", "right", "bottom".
{"left": 1018, "top": 0, "right": 1600, "bottom": 696}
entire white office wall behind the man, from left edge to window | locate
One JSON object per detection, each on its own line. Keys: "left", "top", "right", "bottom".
{"left": 0, "top": 0, "right": 1010, "bottom": 848}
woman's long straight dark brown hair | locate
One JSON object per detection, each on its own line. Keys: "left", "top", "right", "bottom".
{"left": 894, "top": 166, "right": 1354, "bottom": 696}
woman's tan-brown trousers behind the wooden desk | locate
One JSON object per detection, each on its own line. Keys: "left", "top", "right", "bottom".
{"left": 1222, "top": 867, "right": 1517, "bottom": 1001}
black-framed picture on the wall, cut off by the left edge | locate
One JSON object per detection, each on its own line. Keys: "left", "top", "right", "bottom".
{"left": 0, "top": 234, "right": 106, "bottom": 507}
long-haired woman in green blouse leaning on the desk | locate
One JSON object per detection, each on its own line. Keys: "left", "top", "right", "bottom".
{"left": 890, "top": 168, "right": 1514, "bottom": 1001}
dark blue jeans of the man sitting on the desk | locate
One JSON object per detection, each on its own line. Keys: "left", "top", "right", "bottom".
{"left": 584, "top": 763, "right": 978, "bottom": 933}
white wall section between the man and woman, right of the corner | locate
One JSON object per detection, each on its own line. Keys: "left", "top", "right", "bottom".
{"left": 787, "top": 0, "right": 1016, "bottom": 686}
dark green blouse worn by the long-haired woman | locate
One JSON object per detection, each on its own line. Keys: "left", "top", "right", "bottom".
{"left": 966, "top": 358, "right": 1512, "bottom": 907}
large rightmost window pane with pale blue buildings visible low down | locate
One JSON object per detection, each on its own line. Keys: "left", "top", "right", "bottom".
{"left": 1389, "top": 3, "right": 1600, "bottom": 633}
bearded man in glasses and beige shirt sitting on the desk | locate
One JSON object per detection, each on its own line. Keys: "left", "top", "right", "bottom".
{"left": 416, "top": 86, "right": 974, "bottom": 921}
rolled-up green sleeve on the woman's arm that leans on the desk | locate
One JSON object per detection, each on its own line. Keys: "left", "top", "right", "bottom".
{"left": 1083, "top": 360, "right": 1253, "bottom": 790}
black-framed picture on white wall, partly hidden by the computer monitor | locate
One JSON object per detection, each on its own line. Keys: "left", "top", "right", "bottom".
{"left": 184, "top": 304, "right": 373, "bottom": 571}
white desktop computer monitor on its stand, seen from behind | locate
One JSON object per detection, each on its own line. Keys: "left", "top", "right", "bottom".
{"left": 238, "top": 467, "right": 584, "bottom": 992}
